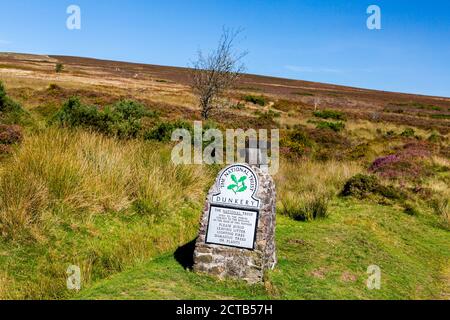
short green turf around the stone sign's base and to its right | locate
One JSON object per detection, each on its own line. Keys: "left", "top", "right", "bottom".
{"left": 76, "top": 200, "right": 450, "bottom": 299}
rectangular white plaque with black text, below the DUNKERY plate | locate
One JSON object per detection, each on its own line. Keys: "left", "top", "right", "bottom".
{"left": 206, "top": 206, "right": 258, "bottom": 250}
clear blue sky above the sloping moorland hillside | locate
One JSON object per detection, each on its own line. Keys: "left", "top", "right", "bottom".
{"left": 0, "top": 0, "right": 450, "bottom": 97}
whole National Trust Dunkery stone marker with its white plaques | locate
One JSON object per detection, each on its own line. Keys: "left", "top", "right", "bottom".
{"left": 194, "top": 164, "right": 276, "bottom": 283}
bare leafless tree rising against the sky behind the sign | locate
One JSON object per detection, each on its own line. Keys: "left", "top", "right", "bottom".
{"left": 191, "top": 29, "right": 247, "bottom": 119}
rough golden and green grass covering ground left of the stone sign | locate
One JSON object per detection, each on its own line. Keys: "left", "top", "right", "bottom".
{"left": 0, "top": 128, "right": 209, "bottom": 299}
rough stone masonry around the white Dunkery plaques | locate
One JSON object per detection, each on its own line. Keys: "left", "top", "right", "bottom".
{"left": 194, "top": 166, "right": 277, "bottom": 283}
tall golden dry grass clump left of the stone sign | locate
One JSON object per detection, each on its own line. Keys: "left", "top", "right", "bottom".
{"left": 0, "top": 129, "right": 204, "bottom": 240}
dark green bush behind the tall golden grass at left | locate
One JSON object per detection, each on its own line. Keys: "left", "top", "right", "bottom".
{"left": 52, "top": 97, "right": 156, "bottom": 138}
